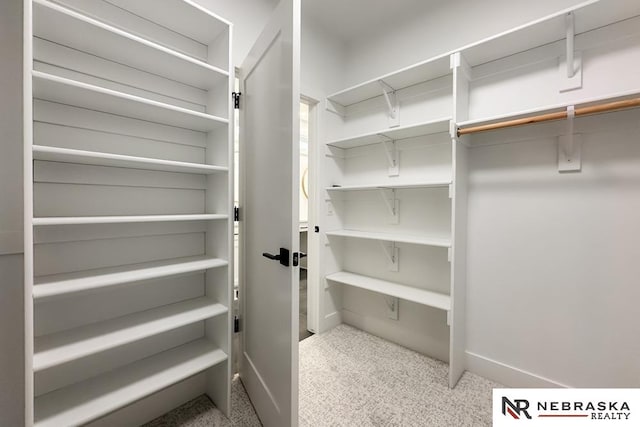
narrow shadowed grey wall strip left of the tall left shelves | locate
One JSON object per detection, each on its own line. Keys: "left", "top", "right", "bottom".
{"left": 0, "top": 0, "right": 24, "bottom": 426}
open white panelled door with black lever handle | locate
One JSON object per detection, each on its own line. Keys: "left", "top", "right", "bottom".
{"left": 239, "top": 0, "right": 300, "bottom": 427}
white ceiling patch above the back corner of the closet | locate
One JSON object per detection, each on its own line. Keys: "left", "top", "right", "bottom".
{"left": 302, "top": 0, "right": 447, "bottom": 42}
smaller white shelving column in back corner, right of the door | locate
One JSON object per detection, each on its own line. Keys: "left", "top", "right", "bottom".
{"left": 323, "top": 54, "right": 466, "bottom": 387}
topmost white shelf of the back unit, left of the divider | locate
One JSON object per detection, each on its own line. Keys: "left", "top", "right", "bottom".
{"left": 327, "top": 53, "right": 451, "bottom": 107}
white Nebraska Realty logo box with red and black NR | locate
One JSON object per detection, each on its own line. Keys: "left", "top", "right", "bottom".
{"left": 493, "top": 389, "right": 640, "bottom": 427}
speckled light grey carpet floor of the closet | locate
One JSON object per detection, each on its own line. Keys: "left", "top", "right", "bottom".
{"left": 145, "top": 325, "right": 500, "bottom": 427}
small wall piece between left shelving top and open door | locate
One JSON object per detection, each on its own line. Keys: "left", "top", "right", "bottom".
{"left": 195, "top": 0, "right": 278, "bottom": 67}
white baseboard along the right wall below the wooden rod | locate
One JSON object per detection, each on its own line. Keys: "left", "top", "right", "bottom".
{"left": 465, "top": 351, "right": 570, "bottom": 388}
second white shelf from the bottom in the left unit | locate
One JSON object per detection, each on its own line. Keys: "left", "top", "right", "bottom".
{"left": 33, "top": 297, "right": 228, "bottom": 372}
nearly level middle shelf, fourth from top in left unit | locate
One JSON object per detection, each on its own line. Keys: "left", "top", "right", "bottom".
{"left": 33, "top": 214, "right": 229, "bottom": 226}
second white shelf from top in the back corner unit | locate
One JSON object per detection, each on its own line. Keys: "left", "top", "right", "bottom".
{"left": 327, "top": 116, "right": 451, "bottom": 149}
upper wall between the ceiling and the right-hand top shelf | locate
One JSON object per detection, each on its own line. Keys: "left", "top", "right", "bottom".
{"left": 336, "top": 0, "right": 584, "bottom": 90}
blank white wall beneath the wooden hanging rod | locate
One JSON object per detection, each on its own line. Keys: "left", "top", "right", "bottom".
{"left": 467, "top": 110, "right": 640, "bottom": 387}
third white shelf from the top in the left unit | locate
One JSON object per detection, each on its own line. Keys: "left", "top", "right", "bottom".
{"left": 33, "top": 145, "right": 229, "bottom": 175}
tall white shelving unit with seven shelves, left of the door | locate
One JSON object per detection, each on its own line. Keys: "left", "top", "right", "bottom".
{"left": 24, "top": 0, "right": 233, "bottom": 426}
